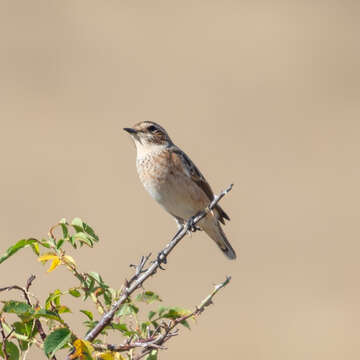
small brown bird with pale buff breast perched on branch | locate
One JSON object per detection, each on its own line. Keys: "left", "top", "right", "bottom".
{"left": 124, "top": 121, "right": 236, "bottom": 259}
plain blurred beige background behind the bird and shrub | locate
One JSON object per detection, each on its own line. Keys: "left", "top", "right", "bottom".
{"left": 0, "top": 0, "right": 360, "bottom": 360}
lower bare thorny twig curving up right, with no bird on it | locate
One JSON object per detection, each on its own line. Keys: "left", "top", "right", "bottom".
{"left": 93, "top": 276, "right": 231, "bottom": 360}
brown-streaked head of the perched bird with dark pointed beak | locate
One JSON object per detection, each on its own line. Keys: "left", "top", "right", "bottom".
{"left": 124, "top": 121, "right": 172, "bottom": 152}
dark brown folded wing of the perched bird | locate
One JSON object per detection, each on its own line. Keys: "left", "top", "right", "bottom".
{"left": 171, "top": 147, "right": 230, "bottom": 224}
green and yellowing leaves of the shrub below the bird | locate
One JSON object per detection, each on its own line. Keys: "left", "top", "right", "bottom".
{"left": 0, "top": 218, "right": 225, "bottom": 360}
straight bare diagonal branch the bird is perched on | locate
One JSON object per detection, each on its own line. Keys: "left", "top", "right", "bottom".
{"left": 85, "top": 184, "right": 233, "bottom": 342}
